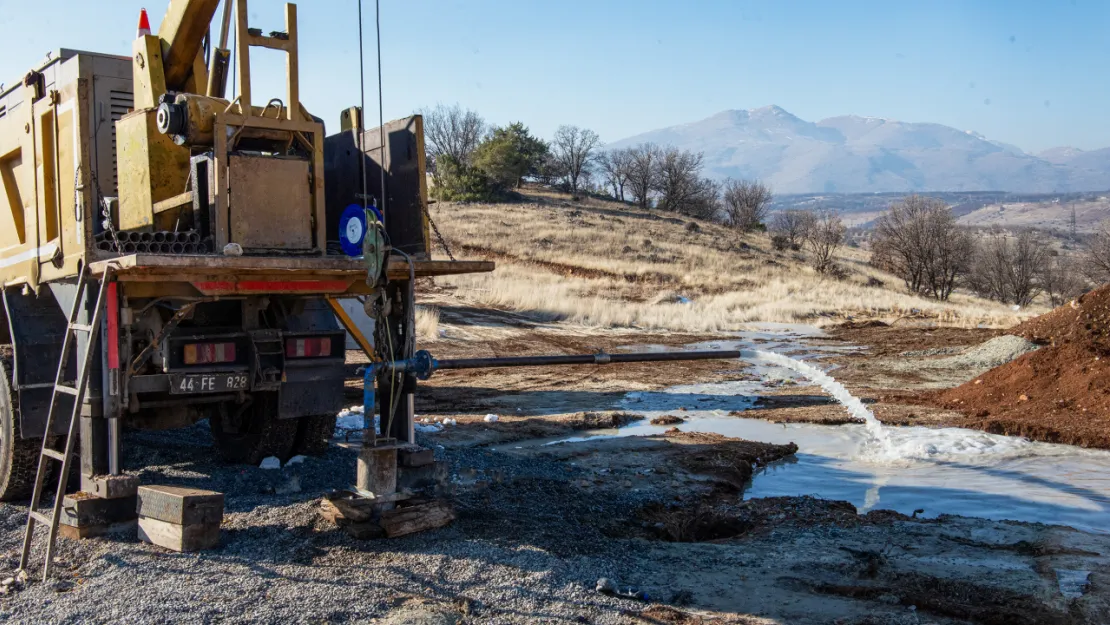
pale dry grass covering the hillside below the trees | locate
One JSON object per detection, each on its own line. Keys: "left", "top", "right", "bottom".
{"left": 433, "top": 187, "right": 1030, "bottom": 331}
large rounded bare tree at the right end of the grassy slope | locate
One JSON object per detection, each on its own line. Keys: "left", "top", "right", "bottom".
{"left": 871, "top": 195, "right": 973, "bottom": 300}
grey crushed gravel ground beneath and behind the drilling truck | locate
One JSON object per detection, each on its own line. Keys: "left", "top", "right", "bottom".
{"left": 0, "top": 422, "right": 692, "bottom": 623}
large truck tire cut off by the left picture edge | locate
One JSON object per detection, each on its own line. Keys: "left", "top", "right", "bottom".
{"left": 0, "top": 353, "right": 42, "bottom": 502}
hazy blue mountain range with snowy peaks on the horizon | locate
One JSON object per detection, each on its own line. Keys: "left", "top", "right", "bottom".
{"left": 608, "top": 105, "right": 1110, "bottom": 193}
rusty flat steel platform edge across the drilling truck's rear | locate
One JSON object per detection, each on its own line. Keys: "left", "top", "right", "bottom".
{"left": 89, "top": 254, "right": 494, "bottom": 296}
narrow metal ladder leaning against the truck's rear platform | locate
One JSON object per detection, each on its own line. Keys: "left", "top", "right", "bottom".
{"left": 19, "top": 265, "right": 111, "bottom": 582}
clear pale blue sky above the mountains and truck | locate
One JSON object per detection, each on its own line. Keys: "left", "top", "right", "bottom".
{"left": 0, "top": 0, "right": 1110, "bottom": 152}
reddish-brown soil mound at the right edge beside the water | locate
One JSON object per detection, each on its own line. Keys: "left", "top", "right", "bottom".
{"left": 936, "top": 285, "right": 1110, "bottom": 448}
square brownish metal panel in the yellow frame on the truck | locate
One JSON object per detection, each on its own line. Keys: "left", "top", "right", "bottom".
{"left": 228, "top": 154, "right": 313, "bottom": 250}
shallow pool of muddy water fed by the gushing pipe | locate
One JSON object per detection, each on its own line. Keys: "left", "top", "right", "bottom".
{"left": 566, "top": 329, "right": 1110, "bottom": 532}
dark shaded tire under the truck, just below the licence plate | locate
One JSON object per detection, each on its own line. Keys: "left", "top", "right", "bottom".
{"left": 209, "top": 393, "right": 297, "bottom": 465}
